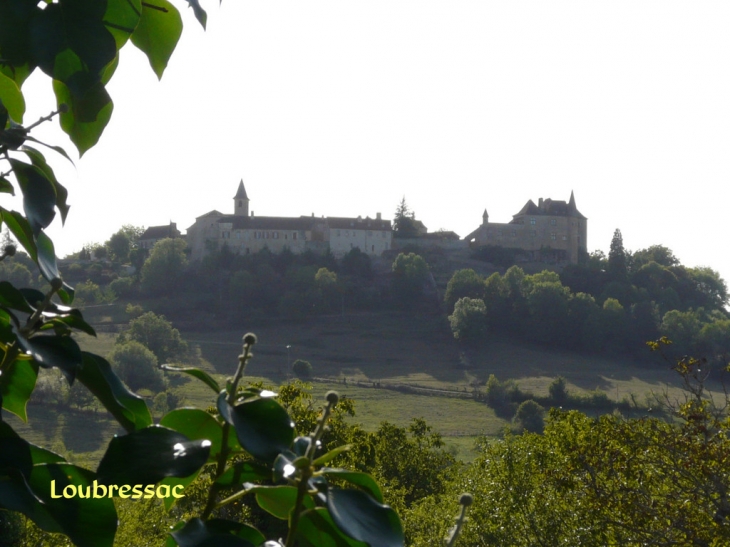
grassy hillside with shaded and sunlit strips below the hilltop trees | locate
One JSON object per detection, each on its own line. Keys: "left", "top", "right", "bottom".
{"left": 10, "top": 309, "right": 692, "bottom": 460}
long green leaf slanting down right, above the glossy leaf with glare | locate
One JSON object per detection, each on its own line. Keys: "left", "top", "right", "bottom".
{"left": 76, "top": 351, "right": 152, "bottom": 431}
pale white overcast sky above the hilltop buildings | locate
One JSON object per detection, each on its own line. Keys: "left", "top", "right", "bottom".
{"left": 14, "top": 0, "right": 730, "bottom": 286}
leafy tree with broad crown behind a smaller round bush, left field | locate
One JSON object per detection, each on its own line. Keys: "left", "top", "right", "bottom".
{"left": 118, "top": 311, "right": 188, "bottom": 363}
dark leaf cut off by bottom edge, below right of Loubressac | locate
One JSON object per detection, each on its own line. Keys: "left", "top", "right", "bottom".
{"left": 170, "top": 518, "right": 266, "bottom": 547}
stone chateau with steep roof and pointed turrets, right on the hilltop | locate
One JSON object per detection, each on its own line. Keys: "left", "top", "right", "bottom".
{"left": 464, "top": 192, "right": 588, "bottom": 263}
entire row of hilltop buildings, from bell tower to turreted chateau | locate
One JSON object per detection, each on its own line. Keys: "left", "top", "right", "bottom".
{"left": 139, "top": 181, "right": 588, "bottom": 262}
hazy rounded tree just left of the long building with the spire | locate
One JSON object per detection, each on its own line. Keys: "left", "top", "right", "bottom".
{"left": 142, "top": 238, "right": 188, "bottom": 294}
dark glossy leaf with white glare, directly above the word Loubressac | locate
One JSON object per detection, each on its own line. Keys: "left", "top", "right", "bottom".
{"left": 97, "top": 425, "right": 210, "bottom": 484}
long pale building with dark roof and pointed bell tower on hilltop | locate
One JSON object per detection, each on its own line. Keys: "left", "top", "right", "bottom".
{"left": 185, "top": 180, "right": 393, "bottom": 260}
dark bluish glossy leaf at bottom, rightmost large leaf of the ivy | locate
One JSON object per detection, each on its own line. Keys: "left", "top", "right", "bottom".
{"left": 327, "top": 488, "right": 404, "bottom": 547}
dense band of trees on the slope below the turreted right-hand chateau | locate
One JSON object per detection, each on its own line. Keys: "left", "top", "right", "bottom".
{"left": 445, "top": 231, "right": 730, "bottom": 358}
